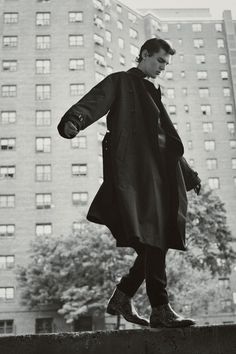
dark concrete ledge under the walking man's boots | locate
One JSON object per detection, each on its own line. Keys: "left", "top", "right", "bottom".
{"left": 0, "top": 325, "right": 236, "bottom": 354}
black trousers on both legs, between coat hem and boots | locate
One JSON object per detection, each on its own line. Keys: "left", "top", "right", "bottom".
{"left": 117, "top": 243, "right": 168, "bottom": 307}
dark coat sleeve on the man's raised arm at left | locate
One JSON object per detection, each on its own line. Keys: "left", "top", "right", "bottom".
{"left": 57, "top": 73, "right": 118, "bottom": 139}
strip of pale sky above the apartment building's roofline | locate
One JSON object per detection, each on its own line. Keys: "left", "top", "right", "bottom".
{"left": 121, "top": 0, "right": 236, "bottom": 20}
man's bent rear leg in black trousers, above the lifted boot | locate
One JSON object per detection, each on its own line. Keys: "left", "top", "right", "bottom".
{"left": 117, "top": 243, "right": 145, "bottom": 297}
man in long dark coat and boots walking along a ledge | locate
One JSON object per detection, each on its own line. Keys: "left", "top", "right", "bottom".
{"left": 58, "top": 38, "right": 201, "bottom": 328}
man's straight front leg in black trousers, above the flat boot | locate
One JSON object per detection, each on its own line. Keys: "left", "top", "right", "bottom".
{"left": 145, "top": 245, "right": 168, "bottom": 307}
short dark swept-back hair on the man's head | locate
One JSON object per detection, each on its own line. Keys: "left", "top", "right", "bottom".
{"left": 135, "top": 38, "right": 176, "bottom": 63}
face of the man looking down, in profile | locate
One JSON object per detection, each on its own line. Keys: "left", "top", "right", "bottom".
{"left": 144, "top": 48, "right": 170, "bottom": 79}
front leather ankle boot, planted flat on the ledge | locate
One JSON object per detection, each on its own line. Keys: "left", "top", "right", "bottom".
{"left": 150, "top": 303, "right": 196, "bottom": 328}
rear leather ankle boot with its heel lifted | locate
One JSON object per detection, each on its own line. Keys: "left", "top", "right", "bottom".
{"left": 106, "top": 288, "right": 149, "bottom": 326}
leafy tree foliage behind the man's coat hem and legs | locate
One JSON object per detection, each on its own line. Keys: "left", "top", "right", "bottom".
{"left": 18, "top": 186, "right": 235, "bottom": 322}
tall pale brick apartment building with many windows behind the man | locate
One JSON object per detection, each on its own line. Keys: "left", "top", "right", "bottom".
{"left": 0, "top": 0, "right": 236, "bottom": 334}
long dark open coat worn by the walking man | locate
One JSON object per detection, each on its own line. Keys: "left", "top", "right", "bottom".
{"left": 58, "top": 68, "right": 201, "bottom": 250}
